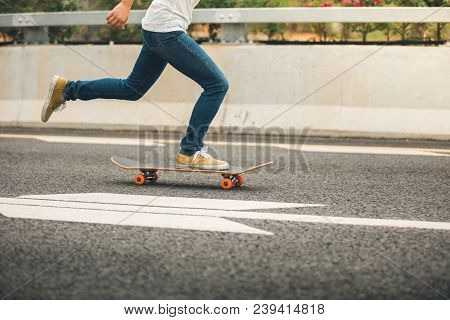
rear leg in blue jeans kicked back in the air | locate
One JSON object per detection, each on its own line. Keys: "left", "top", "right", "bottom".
{"left": 63, "top": 31, "right": 167, "bottom": 101}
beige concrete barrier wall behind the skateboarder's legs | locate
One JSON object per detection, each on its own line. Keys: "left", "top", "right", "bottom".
{"left": 0, "top": 45, "right": 450, "bottom": 139}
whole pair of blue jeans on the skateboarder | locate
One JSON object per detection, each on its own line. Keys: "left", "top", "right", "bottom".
{"left": 63, "top": 30, "right": 228, "bottom": 155}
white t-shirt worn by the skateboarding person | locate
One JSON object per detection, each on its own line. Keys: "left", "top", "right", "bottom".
{"left": 142, "top": 0, "right": 200, "bottom": 32}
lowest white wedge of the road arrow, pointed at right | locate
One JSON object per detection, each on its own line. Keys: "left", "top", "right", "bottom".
{"left": 0, "top": 204, "right": 272, "bottom": 235}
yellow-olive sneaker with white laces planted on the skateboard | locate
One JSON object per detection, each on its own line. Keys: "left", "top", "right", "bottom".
{"left": 176, "top": 147, "right": 230, "bottom": 170}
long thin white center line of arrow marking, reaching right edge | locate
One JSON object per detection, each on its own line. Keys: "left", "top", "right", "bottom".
{"left": 0, "top": 198, "right": 450, "bottom": 232}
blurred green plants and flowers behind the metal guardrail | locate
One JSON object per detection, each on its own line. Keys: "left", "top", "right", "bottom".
{"left": 0, "top": 0, "right": 450, "bottom": 44}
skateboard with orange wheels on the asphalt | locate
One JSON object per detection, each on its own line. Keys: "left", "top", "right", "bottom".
{"left": 111, "top": 157, "right": 273, "bottom": 190}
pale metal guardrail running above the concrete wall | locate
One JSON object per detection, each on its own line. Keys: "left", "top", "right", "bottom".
{"left": 0, "top": 7, "right": 450, "bottom": 42}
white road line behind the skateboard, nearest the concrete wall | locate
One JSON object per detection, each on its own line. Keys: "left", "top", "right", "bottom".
{"left": 0, "top": 134, "right": 450, "bottom": 157}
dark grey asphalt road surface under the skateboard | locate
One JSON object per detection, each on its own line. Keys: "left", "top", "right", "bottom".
{"left": 0, "top": 130, "right": 450, "bottom": 299}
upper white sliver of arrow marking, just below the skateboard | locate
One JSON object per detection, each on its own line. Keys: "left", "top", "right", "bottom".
{"left": 20, "top": 193, "right": 324, "bottom": 210}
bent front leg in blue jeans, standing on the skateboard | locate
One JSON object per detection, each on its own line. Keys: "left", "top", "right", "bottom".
{"left": 157, "top": 33, "right": 228, "bottom": 155}
